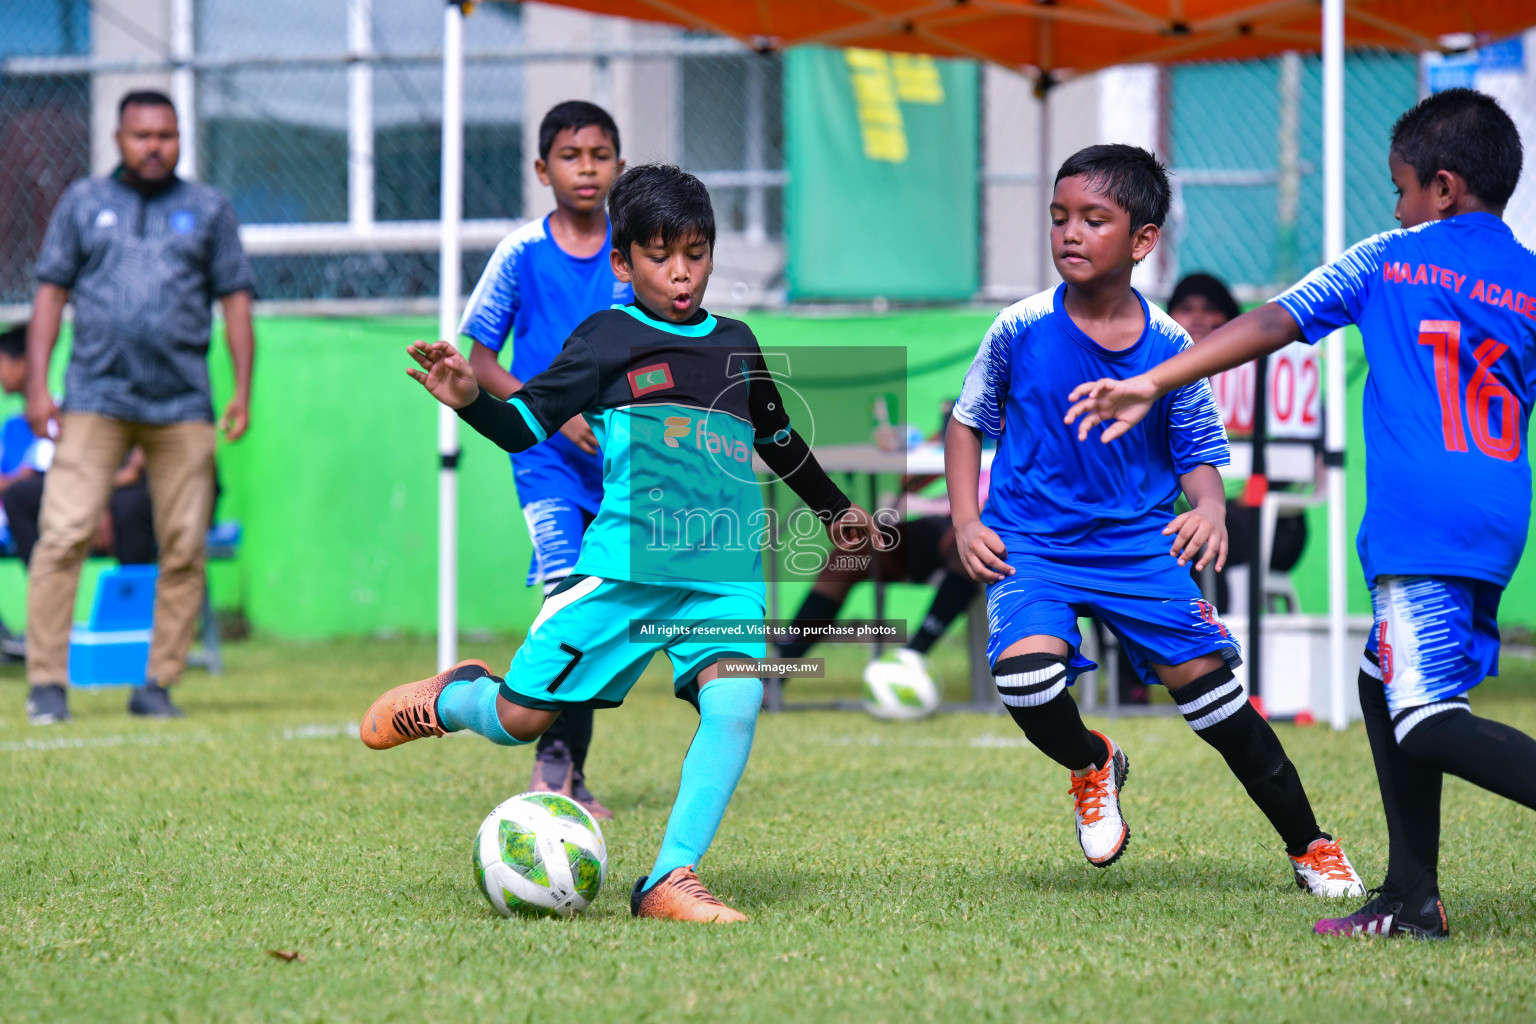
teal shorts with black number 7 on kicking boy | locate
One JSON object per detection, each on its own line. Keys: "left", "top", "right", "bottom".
{"left": 501, "top": 576, "right": 768, "bottom": 711}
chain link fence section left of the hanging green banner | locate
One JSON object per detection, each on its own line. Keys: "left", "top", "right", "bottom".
{"left": 0, "top": 0, "right": 785, "bottom": 306}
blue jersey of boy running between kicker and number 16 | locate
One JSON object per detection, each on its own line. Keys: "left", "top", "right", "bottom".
{"left": 954, "top": 284, "right": 1230, "bottom": 597}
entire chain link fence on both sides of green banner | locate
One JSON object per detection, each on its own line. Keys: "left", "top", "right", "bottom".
{"left": 0, "top": 0, "right": 1536, "bottom": 309}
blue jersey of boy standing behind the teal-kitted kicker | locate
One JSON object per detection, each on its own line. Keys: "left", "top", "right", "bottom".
{"left": 459, "top": 216, "right": 634, "bottom": 513}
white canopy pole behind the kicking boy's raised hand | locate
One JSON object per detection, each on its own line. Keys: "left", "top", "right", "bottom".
{"left": 438, "top": 0, "right": 464, "bottom": 672}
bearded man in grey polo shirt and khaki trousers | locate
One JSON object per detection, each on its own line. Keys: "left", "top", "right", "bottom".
{"left": 26, "top": 92, "right": 255, "bottom": 725}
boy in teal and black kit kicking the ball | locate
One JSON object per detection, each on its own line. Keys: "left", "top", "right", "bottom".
{"left": 361, "top": 164, "right": 874, "bottom": 923}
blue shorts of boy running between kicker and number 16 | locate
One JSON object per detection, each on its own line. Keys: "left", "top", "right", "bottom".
{"left": 986, "top": 573, "right": 1243, "bottom": 685}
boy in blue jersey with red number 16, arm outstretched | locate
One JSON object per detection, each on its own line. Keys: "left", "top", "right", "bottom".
{"left": 1068, "top": 89, "right": 1536, "bottom": 938}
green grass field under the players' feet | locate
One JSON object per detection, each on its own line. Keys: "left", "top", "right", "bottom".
{"left": 0, "top": 640, "right": 1536, "bottom": 1022}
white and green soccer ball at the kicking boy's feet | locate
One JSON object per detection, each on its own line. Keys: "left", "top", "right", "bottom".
{"left": 475, "top": 792, "right": 608, "bottom": 918}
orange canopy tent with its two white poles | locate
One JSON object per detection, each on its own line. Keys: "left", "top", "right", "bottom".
{"left": 438, "top": 0, "right": 1536, "bottom": 729}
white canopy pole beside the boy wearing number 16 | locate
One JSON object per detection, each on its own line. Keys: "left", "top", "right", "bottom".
{"left": 1322, "top": 0, "right": 1350, "bottom": 729}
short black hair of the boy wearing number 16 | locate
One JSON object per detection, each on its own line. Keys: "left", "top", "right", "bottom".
{"left": 1392, "top": 89, "right": 1522, "bottom": 210}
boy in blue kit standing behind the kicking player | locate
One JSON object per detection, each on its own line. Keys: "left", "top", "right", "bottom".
{"left": 459, "top": 100, "right": 634, "bottom": 818}
